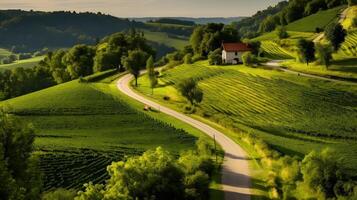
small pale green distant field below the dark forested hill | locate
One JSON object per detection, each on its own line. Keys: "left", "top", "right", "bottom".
{"left": 144, "top": 31, "right": 189, "bottom": 49}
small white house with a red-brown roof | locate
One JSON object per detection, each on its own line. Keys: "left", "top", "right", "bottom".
{"left": 222, "top": 42, "right": 252, "bottom": 64}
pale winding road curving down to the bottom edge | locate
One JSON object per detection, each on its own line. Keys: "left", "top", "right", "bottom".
{"left": 117, "top": 74, "right": 251, "bottom": 200}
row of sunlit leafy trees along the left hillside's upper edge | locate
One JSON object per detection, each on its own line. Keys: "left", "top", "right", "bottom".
{"left": 0, "top": 30, "right": 155, "bottom": 100}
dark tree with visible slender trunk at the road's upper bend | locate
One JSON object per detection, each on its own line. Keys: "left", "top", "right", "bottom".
{"left": 122, "top": 50, "right": 149, "bottom": 87}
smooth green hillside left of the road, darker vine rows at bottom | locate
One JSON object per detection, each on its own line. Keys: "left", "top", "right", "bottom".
{"left": 0, "top": 76, "right": 196, "bottom": 190}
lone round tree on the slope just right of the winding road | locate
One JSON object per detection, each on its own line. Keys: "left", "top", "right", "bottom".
{"left": 178, "top": 79, "right": 203, "bottom": 106}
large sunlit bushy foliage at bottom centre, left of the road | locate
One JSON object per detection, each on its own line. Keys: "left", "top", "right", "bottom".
{"left": 75, "top": 141, "right": 213, "bottom": 200}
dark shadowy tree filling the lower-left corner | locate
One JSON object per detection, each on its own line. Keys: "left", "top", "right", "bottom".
{"left": 0, "top": 111, "right": 41, "bottom": 200}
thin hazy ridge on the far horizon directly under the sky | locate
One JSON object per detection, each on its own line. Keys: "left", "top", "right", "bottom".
{"left": 130, "top": 17, "right": 245, "bottom": 24}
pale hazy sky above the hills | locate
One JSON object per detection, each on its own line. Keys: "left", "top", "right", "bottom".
{"left": 0, "top": 0, "right": 282, "bottom": 17}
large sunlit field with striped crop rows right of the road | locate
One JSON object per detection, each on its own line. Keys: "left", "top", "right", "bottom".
{"left": 134, "top": 62, "right": 357, "bottom": 174}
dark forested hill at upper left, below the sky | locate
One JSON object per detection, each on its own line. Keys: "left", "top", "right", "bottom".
{"left": 0, "top": 10, "right": 192, "bottom": 55}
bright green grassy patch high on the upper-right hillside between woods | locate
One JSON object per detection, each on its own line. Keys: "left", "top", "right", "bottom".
{"left": 286, "top": 6, "right": 346, "bottom": 32}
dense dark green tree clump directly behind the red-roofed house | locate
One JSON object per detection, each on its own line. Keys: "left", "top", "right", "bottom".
{"left": 190, "top": 24, "right": 240, "bottom": 56}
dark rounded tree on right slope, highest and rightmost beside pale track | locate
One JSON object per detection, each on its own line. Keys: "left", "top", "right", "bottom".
{"left": 325, "top": 23, "right": 347, "bottom": 51}
